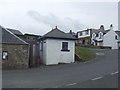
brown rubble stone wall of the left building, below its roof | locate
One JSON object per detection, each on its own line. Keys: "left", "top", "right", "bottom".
{"left": 2, "top": 44, "right": 29, "bottom": 69}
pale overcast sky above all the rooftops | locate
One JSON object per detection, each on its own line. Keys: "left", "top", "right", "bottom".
{"left": 0, "top": 0, "right": 118, "bottom": 35}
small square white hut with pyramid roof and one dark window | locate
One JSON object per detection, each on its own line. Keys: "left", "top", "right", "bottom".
{"left": 40, "top": 26, "right": 76, "bottom": 65}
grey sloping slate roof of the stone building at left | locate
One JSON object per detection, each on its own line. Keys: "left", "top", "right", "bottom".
{"left": 0, "top": 26, "right": 28, "bottom": 44}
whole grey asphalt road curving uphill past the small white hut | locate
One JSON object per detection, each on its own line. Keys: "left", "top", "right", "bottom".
{"left": 2, "top": 49, "right": 118, "bottom": 88}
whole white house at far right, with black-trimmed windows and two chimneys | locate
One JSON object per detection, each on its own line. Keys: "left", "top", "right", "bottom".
{"left": 91, "top": 25, "right": 120, "bottom": 49}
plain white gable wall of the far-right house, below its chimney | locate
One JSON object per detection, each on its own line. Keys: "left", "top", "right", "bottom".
{"left": 103, "top": 30, "right": 118, "bottom": 49}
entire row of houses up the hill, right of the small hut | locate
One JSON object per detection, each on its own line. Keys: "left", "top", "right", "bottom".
{"left": 77, "top": 24, "right": 120, "bottom": 49}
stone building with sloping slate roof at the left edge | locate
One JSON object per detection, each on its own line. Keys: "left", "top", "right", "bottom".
{"left": 0, "top": 26, "right": 29, "bottom": 69}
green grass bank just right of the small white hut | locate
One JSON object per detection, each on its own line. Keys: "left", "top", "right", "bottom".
{"left": 75, "top": 46, "right": 96, "bottom": 61}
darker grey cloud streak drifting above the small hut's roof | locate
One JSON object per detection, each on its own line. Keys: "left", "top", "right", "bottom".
{"left": 28, "top": 11, "right": 85, "bottom": 32}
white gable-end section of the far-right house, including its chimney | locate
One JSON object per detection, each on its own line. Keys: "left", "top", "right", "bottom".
{"left": 103, "top": 26, "right": 120, "bottom": 49}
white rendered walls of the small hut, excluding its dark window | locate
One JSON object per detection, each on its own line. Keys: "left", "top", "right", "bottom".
{"left": 43, "top": 39, "right": 75, "bottom": 65}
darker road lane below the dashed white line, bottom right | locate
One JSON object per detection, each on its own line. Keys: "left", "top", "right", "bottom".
{"left": 62, "top": 73, "right": 118, "bottom": 88}
